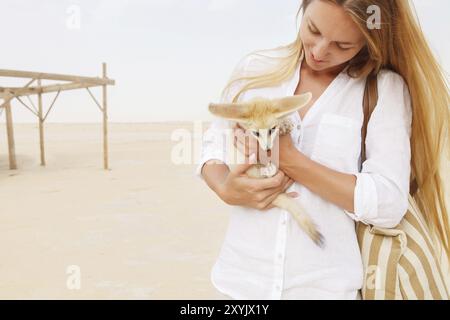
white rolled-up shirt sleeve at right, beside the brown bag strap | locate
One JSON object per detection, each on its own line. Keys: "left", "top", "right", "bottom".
{"left": 344, "top": 70, "right": 412, "bottom": 228}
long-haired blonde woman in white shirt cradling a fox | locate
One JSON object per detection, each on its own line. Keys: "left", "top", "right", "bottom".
{"left": 197, "top": 0, "right": 450, "bottom": 299}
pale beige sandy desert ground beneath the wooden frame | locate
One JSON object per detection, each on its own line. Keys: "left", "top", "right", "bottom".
{"left": 0, "top": 123, "right": 448, "bottom": 299}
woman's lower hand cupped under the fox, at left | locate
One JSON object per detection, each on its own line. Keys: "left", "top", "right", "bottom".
{"left": 218, "top": 157, "right": 298, "bottom": 211}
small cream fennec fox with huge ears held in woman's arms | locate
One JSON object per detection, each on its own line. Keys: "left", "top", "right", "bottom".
{"left": 209, "top": 92, "right": 324, "bottom": 247}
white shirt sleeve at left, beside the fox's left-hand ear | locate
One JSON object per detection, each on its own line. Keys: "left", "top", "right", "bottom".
{"left": 195, "top": 55, "right": 253, "bottom": 180}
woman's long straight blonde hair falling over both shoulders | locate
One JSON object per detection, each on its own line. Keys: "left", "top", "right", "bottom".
{"left": 222, "top": 0, "right": 450, "bottom": 259}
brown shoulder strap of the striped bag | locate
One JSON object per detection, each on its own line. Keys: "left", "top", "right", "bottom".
{"left": 359, "top": 73, "right": 418, "bottom": 196}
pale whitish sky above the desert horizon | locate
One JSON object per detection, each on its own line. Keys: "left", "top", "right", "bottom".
{"left": 0, "top": 0, "right": 450, "bottom": 122}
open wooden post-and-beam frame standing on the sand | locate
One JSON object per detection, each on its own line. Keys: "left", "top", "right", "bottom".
{"left": 0, "top": 63, "right": 115, "bottom": 169}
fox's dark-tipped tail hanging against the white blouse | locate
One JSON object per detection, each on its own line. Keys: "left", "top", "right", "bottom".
{"left": 272, "top": 193, "right": 325, "bottom": 248}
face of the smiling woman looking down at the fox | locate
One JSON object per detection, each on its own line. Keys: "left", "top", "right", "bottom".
{"left": 300, "top": 0, "right": 366, "bottom": 72}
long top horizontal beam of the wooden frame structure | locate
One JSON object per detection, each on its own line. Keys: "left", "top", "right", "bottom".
{"left": 0, "top": 69, "right": 114, "bottom": 85}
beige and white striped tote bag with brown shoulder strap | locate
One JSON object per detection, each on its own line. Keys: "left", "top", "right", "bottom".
{"left": 356, "top": 75, "right": 449, "bottom": 300}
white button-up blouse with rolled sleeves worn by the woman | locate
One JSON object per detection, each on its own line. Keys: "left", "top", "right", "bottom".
{"left": 196, "top": 50, "right": 412, "bottom": 299}
